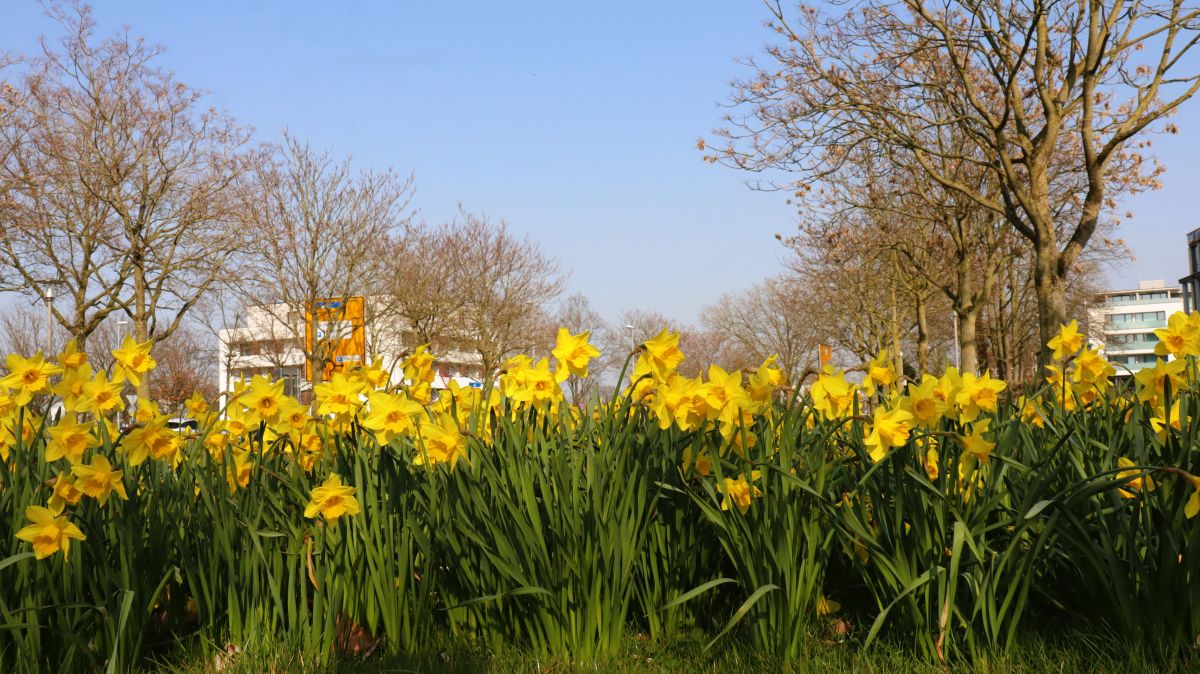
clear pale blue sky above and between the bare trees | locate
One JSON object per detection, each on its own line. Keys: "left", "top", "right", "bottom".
{"left": 0, "top": 0, "right": 1200, "bottom": 321}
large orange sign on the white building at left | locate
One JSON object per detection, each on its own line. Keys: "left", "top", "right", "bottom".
{"left": 304, "top": 297, "right": 367, "bottom": 381}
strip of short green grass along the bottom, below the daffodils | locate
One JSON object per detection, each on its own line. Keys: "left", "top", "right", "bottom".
{"left": 143, "top": 631, "right": 1200, "bottom": 674}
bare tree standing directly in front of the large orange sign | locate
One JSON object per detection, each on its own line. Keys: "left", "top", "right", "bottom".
{"left": 229, "top": 134, "right": 413, "bottom": 384}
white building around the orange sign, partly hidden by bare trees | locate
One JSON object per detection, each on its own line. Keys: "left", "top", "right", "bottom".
{"left": 217, "top": 299, "right": 482, "bottom": 401}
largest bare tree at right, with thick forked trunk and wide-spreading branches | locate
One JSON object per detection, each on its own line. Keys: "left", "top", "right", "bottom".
{"left": 710, "top": 0, "right": 1200, "bottom": 357}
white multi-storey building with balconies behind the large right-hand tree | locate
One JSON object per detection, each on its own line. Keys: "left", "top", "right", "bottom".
{"left": 1087, "top": 281, "right": 1183, "bottom": 377}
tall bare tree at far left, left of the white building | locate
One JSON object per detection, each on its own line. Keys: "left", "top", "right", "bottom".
{"left": 0, "top": 2, "right": 248, "bottom": 395}
